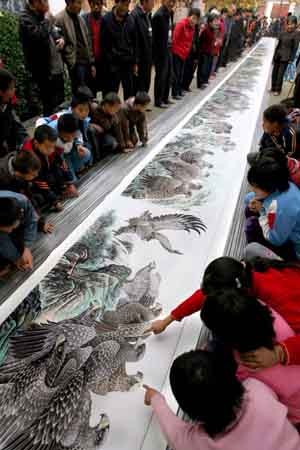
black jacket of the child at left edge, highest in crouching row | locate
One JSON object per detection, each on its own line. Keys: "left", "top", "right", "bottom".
{"left": 0, "top": 103, "right": 27, "bottom": 157}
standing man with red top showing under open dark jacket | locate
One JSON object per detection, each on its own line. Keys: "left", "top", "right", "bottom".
{"left": 82, "top": 0, "right": 103, "bottom": 97}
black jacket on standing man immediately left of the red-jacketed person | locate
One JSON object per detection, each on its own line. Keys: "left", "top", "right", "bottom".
{"left": 152, "top": 6, "right": 173, "bottom": 62}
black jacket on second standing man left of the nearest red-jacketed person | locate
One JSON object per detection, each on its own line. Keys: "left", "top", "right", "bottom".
{"left": 131, "top": 5, "right": 152, "bottom": 64}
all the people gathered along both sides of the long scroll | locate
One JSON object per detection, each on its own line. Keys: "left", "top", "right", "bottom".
{"left": 0, "top": 0, "right": 300, "bottom": 450}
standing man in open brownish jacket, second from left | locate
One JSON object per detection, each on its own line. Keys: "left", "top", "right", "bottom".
{"left": 56, "top": 0, "right": 96, "bottom": 95}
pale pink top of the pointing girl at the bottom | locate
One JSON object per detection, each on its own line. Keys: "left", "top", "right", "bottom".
{"left": 151, "top": 379, "right": 300, "bottom": 450}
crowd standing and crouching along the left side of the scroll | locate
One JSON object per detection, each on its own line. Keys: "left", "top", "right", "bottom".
{"left": 0, "top": 0, "right": 260, "bottom": 277}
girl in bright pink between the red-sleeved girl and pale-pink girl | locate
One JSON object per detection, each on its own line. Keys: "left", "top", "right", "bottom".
{"left": 201, "top": 289, "right": 300, "bottom": 423}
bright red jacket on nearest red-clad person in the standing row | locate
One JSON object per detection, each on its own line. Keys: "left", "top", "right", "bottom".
{"left": 172, "top": 17, "right": 195, "bottom": 61}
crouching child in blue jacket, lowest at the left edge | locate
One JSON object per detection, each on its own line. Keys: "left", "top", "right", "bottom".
{"left": 0, "top": 191, "right": 38, "bottom": 276}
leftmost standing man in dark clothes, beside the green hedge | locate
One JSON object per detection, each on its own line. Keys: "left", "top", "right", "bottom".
{"left": 20, "top": 0, "right": 64, "bottom": 116}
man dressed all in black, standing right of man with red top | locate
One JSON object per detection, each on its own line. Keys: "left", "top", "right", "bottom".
{"left": 101, "top": 0, "right": 139, "bottom": 100}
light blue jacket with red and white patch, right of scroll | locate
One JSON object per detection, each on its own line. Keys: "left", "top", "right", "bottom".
{"left": 246, "top": 183, "right": 300, "bottom": 259}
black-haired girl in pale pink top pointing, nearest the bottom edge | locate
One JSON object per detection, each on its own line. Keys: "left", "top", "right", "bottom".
{"left": 145, "top": 350, "right": 300, "bottom": 450}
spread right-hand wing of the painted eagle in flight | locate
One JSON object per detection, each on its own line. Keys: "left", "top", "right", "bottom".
{"left": 152, "top": 214, "right": 206, "bottom": 234}
